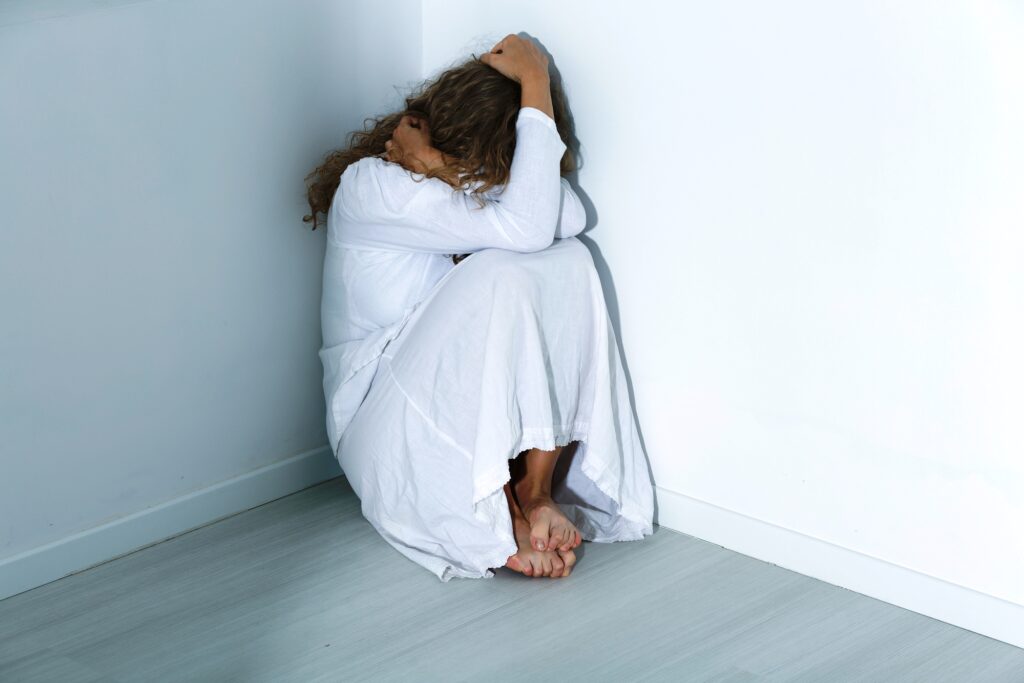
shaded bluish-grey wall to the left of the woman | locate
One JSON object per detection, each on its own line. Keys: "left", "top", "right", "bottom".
{"left": 0, "top": 0, "right": 421, "bottom": 559}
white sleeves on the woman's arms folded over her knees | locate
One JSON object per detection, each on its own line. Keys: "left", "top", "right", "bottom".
{"left": 331, "top": 106, "right": 569, "bottom": 254}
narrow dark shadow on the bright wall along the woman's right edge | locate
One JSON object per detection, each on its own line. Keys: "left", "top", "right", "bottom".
{"left": 536, "top": 32, "right": 658, "bottom": 523}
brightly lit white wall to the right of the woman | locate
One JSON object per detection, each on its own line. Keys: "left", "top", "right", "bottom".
{"left": 423, "top": 0, "right": 1024, "bottom": 605}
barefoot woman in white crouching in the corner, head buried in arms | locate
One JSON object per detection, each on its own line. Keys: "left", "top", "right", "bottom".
{"left": 304, "top": 35, "right": 653, "bottom": 581}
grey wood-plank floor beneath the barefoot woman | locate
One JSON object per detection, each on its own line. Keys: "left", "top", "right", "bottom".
{"left": 0, "top": 477, "right": 1024, "bottom": 683}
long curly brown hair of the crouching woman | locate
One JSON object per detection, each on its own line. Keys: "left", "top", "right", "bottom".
{"left": 302, "top": 54, "right": 577, "bottom": 236}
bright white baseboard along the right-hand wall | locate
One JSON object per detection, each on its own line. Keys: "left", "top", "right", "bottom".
{"left": 656, "top": 486, "right": 1024, "bottom": 647}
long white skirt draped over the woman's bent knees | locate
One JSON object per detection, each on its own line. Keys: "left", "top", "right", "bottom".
{"left": 338, "top": 238, "right": 653, "bottom": 581}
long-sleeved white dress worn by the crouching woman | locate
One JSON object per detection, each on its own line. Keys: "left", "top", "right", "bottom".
{"left": 319, "top": 108, "right": 653, "bottom": 581}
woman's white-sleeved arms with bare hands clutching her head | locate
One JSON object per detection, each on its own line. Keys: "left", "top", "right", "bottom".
{"left": 331, "top": 35, "right": 586, "bottom": 254}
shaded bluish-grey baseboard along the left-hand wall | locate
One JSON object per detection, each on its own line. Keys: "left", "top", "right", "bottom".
{"left": 0, "top": 445, "right": 342, "bottom": 600}
